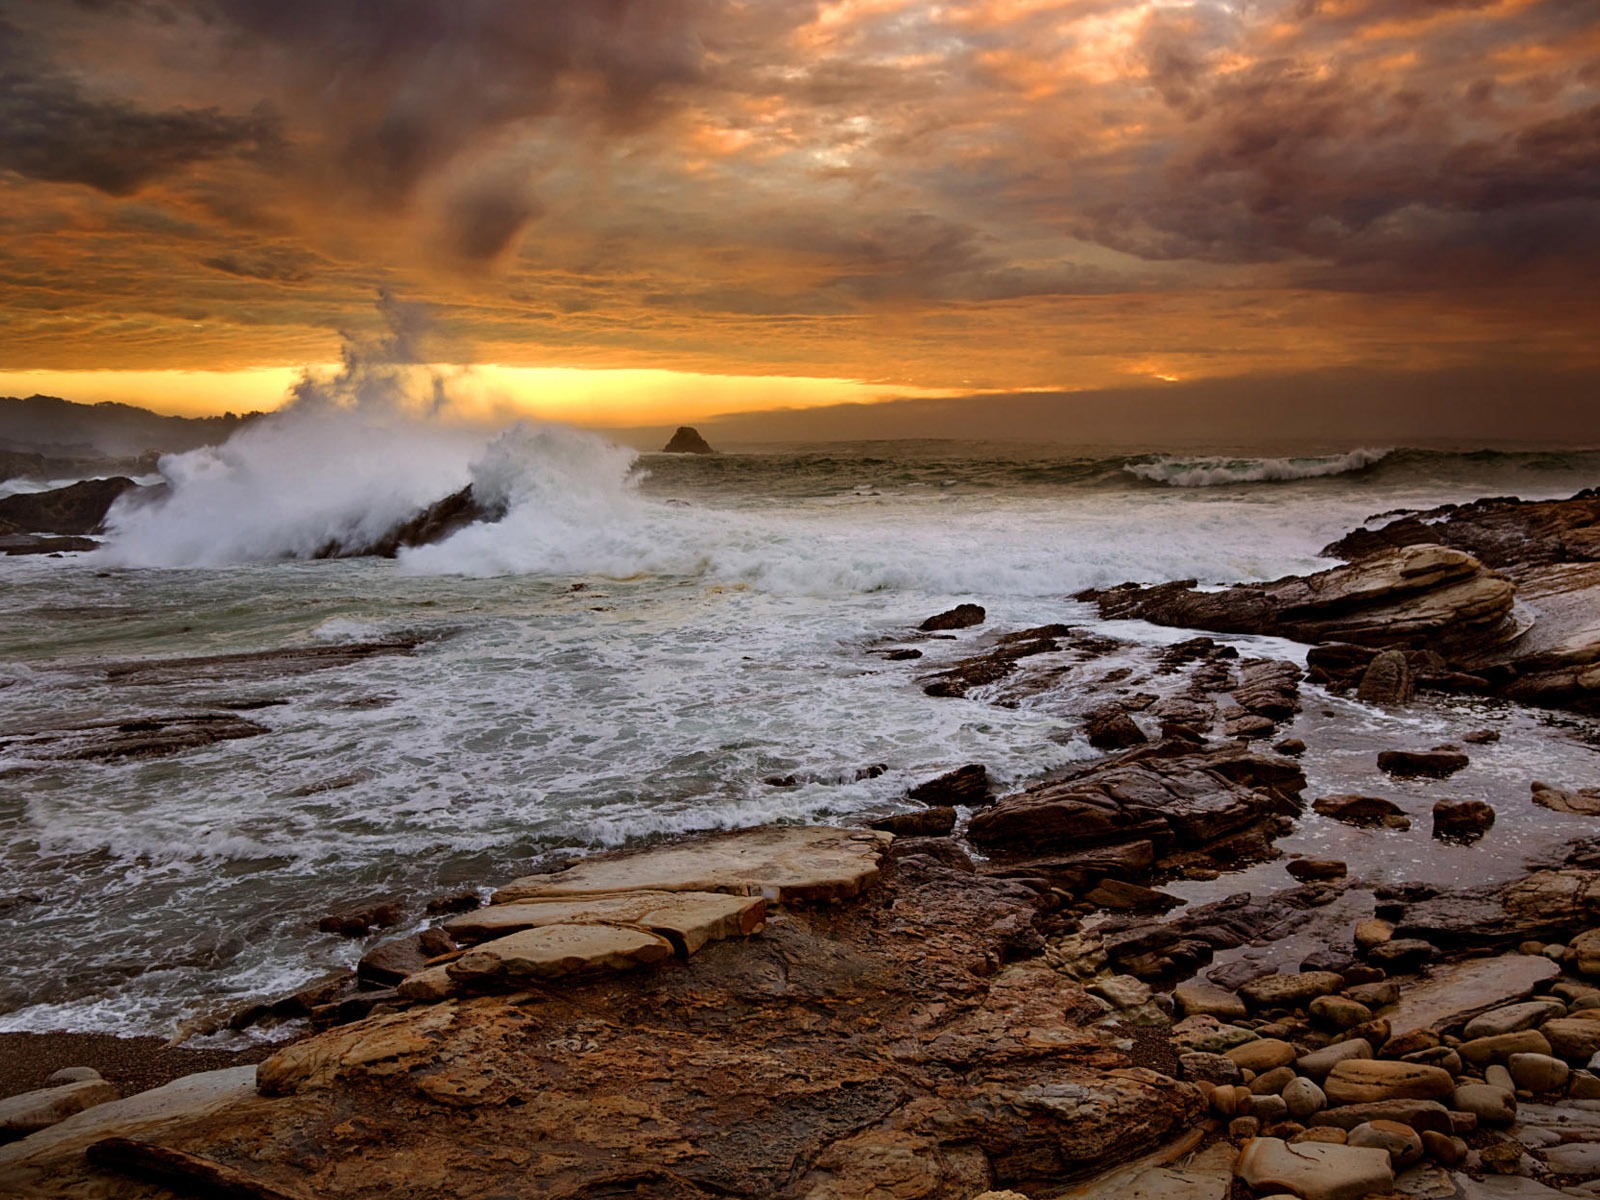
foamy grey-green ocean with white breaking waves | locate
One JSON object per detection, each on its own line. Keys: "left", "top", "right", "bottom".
{"left": 0, "top": 422, "right": 1600, "bottom": 1038}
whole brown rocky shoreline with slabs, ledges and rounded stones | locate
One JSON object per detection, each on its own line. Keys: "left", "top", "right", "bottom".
{"left": 9, "top": 493, "right": 1600, "bottom": 1200}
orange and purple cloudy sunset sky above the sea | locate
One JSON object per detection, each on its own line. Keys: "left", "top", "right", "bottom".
{"left": 0, "top": 0, "right": 1600, "bottom": 438}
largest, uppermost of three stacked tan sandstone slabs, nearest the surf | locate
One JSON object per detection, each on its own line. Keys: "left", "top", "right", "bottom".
{"left": 493, "top": 826, "right": 894, "bottom": 904}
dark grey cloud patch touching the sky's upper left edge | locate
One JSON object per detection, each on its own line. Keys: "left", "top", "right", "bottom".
{"left": 0, "top": 18, "right": 282, "bottom": 195}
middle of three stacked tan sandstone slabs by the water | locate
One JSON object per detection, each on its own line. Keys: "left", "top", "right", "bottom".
{"left": 445, "top": 891, "right": 766, "bottom": 954}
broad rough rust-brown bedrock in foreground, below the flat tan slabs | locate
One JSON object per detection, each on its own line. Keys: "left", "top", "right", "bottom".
{"left": 15, "top": 851, "right": 1202, "bottom": 1200}
